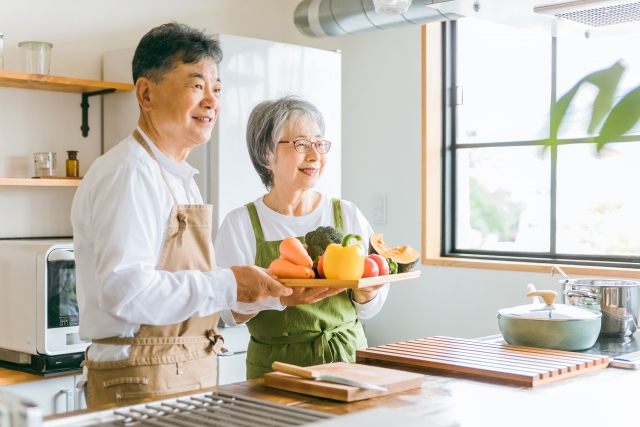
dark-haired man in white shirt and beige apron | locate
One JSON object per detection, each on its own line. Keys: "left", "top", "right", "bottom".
{"left": 71, "top": 23, "right": 291, "bottom": 407}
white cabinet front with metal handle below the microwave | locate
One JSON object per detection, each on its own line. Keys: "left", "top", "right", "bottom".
{"left": 0, "top": 376, "right": 75, "bottom": 416}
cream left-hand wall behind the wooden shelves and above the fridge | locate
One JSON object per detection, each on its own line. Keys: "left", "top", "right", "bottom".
{"left": 0, "top": 0, "right": 322, "bottom": 238}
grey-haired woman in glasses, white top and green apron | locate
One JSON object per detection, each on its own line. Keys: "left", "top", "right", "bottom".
{"left": 215, "top": 96, "right": 389, "bottom": 379}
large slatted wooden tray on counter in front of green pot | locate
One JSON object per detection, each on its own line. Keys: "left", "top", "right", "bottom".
{"left": 356, "top": 337, "right": 609, "bottom": 387}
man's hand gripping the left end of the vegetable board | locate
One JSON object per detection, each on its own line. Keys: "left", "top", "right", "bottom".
{"left": 231, "top": 265, "right": 292, "bottom": 302}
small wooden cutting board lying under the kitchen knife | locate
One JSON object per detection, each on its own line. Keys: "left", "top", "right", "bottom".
{"left": 264, "top": 362, "right": 424, "bottom": 402}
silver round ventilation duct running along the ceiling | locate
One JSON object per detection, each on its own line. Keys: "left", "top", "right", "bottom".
{"left": 293, "top": 0, "right": 460, "bottom": 37}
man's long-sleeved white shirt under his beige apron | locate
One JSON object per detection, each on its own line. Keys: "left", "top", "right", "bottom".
{"left": 71, "top": 129, "right": 237, "bottom": 361}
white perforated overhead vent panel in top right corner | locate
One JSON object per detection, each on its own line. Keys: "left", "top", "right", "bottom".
{"left": 534, "top": 0, "right": 640, "bottom": 27}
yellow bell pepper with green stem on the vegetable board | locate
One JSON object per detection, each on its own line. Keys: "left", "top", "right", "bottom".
{"left": 322, "top": 234, "right": 365, "bottom": 280}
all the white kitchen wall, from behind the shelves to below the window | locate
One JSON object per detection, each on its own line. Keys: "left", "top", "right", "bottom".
{"left": 0, "top": 0, "right": 576, "bottom": 345}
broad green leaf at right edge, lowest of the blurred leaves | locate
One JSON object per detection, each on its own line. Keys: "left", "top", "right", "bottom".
{"left": 595, "top": 86, "right": 640, "bottom": 151}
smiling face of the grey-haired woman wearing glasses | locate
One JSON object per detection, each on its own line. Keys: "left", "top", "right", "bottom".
{"left": 269, "top": 118, "right": 328, "bottom": 191}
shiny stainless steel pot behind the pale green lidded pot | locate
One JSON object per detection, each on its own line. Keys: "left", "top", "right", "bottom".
{"left": 560, "top": 279, "right": 640, "bottom": 337}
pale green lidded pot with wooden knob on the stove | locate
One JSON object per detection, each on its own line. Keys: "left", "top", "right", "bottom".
{"left": 498, "top": 291, "right": 602, "bottom": 351}
